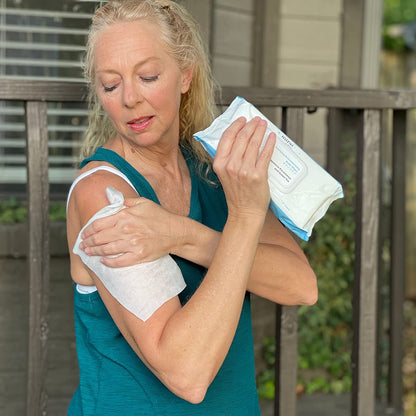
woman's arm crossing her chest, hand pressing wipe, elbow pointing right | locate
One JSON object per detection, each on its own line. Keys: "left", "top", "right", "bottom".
{"left": 79, "top": 192, "right": 318, "bottom": 305}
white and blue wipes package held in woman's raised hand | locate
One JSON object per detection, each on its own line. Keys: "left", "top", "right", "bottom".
{"left": 194, "top": 97, "right": 344, "bottom": 241}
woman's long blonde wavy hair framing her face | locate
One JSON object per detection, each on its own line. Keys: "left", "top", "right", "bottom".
{"left": 81, "top": 0, "right": 218, "bottom": 169}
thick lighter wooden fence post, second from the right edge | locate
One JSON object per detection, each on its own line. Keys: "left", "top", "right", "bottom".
{"left": 351, "top": 110, "right": 381, "bottom": 416}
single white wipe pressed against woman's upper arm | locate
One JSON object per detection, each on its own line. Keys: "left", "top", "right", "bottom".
{"left": 73, "top": 187, "right": 186, "bottom": 321}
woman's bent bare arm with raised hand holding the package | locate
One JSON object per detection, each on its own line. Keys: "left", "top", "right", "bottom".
{"left": 70, "top": 116, "right": 274, "bottom": 403}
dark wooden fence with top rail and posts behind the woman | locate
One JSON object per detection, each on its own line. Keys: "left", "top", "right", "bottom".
{"left": 0, "top": 80, "right": 416, "bottom": 416}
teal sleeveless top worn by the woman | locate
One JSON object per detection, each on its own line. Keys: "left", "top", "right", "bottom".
{"left": 68, "top": 148, "right": 260, "bottom": 416}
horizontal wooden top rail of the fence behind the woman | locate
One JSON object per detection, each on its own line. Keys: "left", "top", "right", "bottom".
{"left": 0, "top": 79, "right": 416, "bottom": 110}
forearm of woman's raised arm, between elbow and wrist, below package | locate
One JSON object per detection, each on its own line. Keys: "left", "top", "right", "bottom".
{"left": 152, "top": 216, "right": 261, "bottom": 394}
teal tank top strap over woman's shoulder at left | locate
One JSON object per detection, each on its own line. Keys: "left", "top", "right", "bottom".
{"left": 81, "top": 147, "right": 160, "bottom": 205}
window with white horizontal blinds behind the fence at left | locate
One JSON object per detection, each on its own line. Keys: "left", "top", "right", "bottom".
{"left": 0, "top": 0, "right": 104, "bottom": 195}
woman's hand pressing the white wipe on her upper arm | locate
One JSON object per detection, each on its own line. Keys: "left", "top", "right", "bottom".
{"left": 80, "top": 197, "right": 183, "bottom": 267}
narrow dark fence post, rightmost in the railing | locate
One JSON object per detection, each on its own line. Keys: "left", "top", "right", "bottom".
{"left": 388, "top": 110, "right": 407, "bottom": 412}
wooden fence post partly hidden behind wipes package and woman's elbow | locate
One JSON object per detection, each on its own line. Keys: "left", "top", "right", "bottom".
{"left": 274, "top": 108, "right": 304, "bottom": 416}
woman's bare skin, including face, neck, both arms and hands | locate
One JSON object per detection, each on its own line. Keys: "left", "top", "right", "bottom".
{"left": 68, "top": 21, "right": 317, "bottom": 403}
